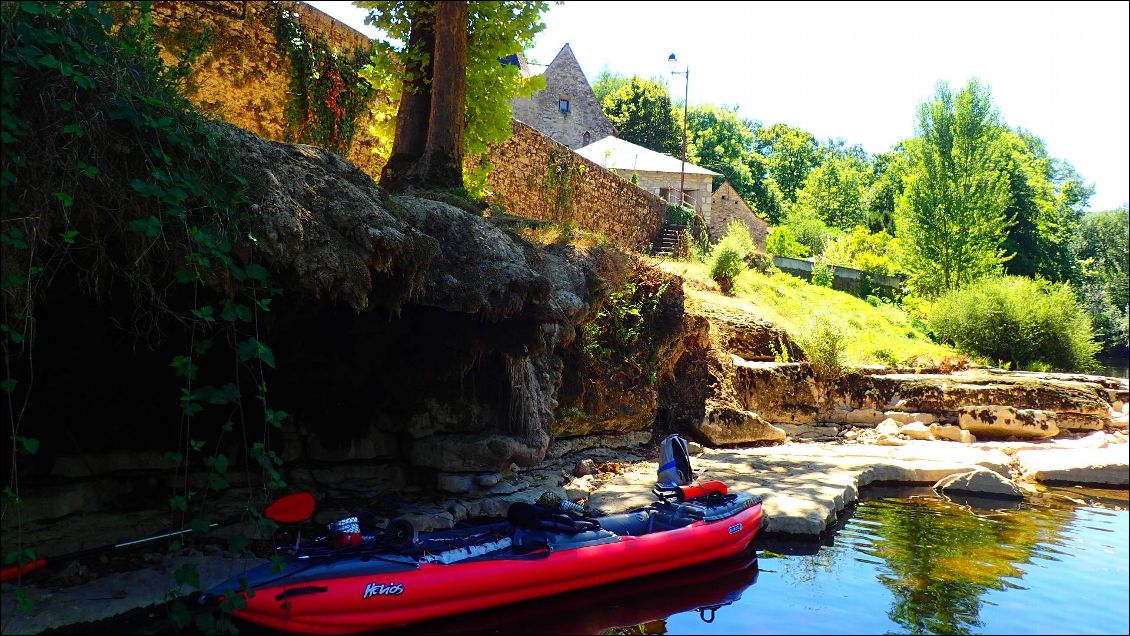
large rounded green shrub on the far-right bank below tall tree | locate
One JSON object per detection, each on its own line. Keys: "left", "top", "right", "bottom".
{"left": 930, "top": 276, "right": 1098, "bottom": 371}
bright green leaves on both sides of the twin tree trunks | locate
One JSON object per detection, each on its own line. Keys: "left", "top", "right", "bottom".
{"left": 354, "top": 1, "right": 548, "bottom": 188}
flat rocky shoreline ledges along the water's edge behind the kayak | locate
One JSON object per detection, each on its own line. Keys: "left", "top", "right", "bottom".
{"left": 0, "top": 413, "right": 1130, "bottom": 634}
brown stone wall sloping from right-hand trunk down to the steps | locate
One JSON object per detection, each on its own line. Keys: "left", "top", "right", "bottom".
{"left": 487, "top": 120, "right": 667, "bottom": 252}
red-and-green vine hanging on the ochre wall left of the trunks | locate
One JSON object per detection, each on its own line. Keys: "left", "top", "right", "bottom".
{"left": 275, "top": 2, "right": 373, "bottom": 157}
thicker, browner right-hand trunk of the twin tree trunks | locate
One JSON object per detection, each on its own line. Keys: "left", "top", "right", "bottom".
{"left": 412, "top": 0, "right": 468, "bottom": 188}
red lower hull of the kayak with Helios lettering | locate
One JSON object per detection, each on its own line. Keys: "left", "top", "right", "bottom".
{"left": 222, "top": 503, "right": 762, "bottom": 634}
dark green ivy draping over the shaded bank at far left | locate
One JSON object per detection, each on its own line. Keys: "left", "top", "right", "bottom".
{"left": 0, "top": 1, "right": 287, "bottom": 631}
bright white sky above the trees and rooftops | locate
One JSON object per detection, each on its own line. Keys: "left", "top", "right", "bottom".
{"left": 308, "top": 1, "right": 1130, "bottom": 210}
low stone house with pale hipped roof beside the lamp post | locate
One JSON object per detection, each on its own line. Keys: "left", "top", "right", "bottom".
{"left": 576, "top": 137, "right": 724, "bottom": 220}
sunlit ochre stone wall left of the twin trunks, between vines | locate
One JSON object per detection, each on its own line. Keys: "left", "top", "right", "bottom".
{"left": 153, "top": 1, "right": 385, "bottom": 178}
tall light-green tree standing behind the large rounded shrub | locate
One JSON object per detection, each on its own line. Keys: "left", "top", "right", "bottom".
{"left": 895, "top": 79, "right": 1010, "bottom": 296}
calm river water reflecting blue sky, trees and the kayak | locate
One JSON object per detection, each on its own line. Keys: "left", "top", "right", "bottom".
{"left": 411, "top": 489, "right": 1130, "bottom": 634}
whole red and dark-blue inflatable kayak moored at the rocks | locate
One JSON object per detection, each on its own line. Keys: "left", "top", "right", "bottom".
{"left": 201, "top": 486, "right": 762, "bottom": 634}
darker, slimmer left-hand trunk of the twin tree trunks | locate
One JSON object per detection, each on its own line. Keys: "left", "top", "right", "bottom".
{"left": 381, "top": 2, "right": 431, "bottom": 190}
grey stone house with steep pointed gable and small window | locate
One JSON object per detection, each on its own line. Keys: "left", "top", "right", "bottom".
{"left": 513, "top": 44, "right": 616, "bottom": 150}
